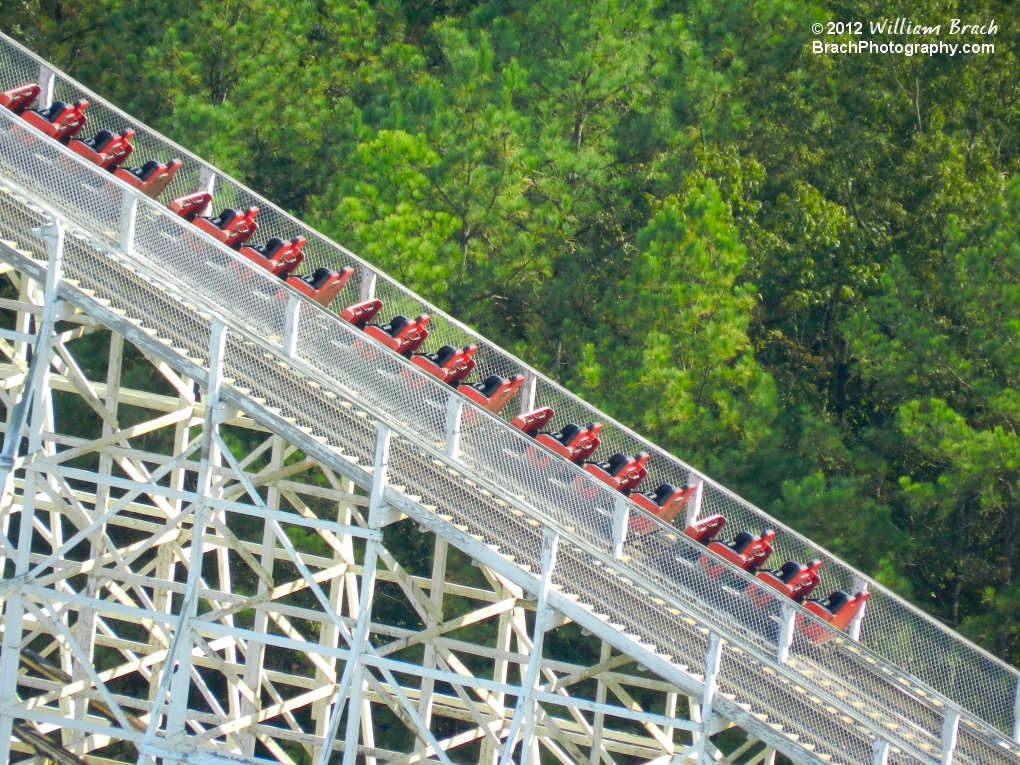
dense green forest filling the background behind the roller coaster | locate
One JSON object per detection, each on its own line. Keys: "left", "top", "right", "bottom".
{"left": 0, "top": 0, "right": 1020, "bottom": 665}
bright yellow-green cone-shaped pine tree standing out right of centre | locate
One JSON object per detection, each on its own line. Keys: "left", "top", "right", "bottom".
{"left": 579, "top": 182, "right": 775, "bottom": 473}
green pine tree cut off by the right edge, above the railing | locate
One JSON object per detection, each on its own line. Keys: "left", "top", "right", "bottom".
{"left": 849, "top": 179, "right": 1020, "bottom": 660}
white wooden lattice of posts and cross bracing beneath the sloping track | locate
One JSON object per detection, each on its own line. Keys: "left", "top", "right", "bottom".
{"left": 0, "top": 259, "right": 774, "bottom": 765}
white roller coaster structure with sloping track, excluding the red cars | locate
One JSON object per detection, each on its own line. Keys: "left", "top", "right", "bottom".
{"left": 0, "top": 31, "right": 1020, "bottom": 765}
